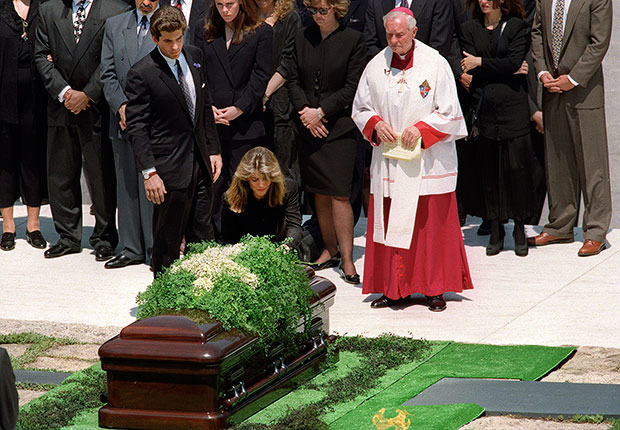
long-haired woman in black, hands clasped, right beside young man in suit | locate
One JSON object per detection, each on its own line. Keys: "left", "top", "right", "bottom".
{"left": 201, "top": 0, "right": 273, "bottom": 233}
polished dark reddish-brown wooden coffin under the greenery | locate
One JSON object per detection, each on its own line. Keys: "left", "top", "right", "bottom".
{"left": 99, "top": 269, "right": 336, "bottom": 430}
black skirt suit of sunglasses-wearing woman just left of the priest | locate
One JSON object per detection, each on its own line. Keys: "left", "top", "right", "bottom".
{"left": 287, "top": 24, "right": 366, "bottom": 197}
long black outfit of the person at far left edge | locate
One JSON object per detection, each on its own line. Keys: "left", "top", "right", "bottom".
{"left": 0, "top": 0, "right": 47, "bottom": 208}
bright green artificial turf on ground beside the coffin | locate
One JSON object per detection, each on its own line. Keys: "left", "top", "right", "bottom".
{"left": 50, "top": 342, "right": 576, "bottom": 430}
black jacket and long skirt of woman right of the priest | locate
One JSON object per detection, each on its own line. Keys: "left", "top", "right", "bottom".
{"left": 461, "top": 17, "right": 539, "bottom": 222}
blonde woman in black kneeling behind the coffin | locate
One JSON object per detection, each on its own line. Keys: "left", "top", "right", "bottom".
{"left": 222, "top": 146, "right": 302, "bottom": 249}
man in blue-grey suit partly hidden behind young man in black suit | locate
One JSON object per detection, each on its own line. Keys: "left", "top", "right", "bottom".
{"left": 101, "top": 0, "right": 158, "bottom": 269}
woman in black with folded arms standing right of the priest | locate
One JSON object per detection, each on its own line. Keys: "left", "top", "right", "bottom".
{"left": 461, "top": 0, "right": 538, "bottom": 257}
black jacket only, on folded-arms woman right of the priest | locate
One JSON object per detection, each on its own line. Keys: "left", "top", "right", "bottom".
{"left": 461, "top": 17, "right": 530, "bottom": 139}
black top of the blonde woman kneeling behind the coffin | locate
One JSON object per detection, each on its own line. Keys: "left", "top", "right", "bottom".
{"left": 222, "top": 178, "right": 302, "bottom": 248}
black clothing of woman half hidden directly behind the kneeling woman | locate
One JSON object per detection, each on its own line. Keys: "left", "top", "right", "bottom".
{"left": 265, "top": 10, "right": 301, "bottom": 183}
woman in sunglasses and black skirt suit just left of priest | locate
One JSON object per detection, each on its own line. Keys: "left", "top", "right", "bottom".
{"left": 287, "top": 0, "right": 366, "bottom": 284}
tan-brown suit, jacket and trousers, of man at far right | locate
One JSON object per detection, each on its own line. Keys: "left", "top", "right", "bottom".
{"left": 532, "top": 0, "right": 613, "bottom": 244}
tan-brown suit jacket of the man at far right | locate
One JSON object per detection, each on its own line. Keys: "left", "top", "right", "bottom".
{"left": 532, "top": 0, "right": 613, "bottom": 109}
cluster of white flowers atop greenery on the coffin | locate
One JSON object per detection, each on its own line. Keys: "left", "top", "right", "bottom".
{"left": 171, "top": 243, "right": 259, "bottom": 296}
